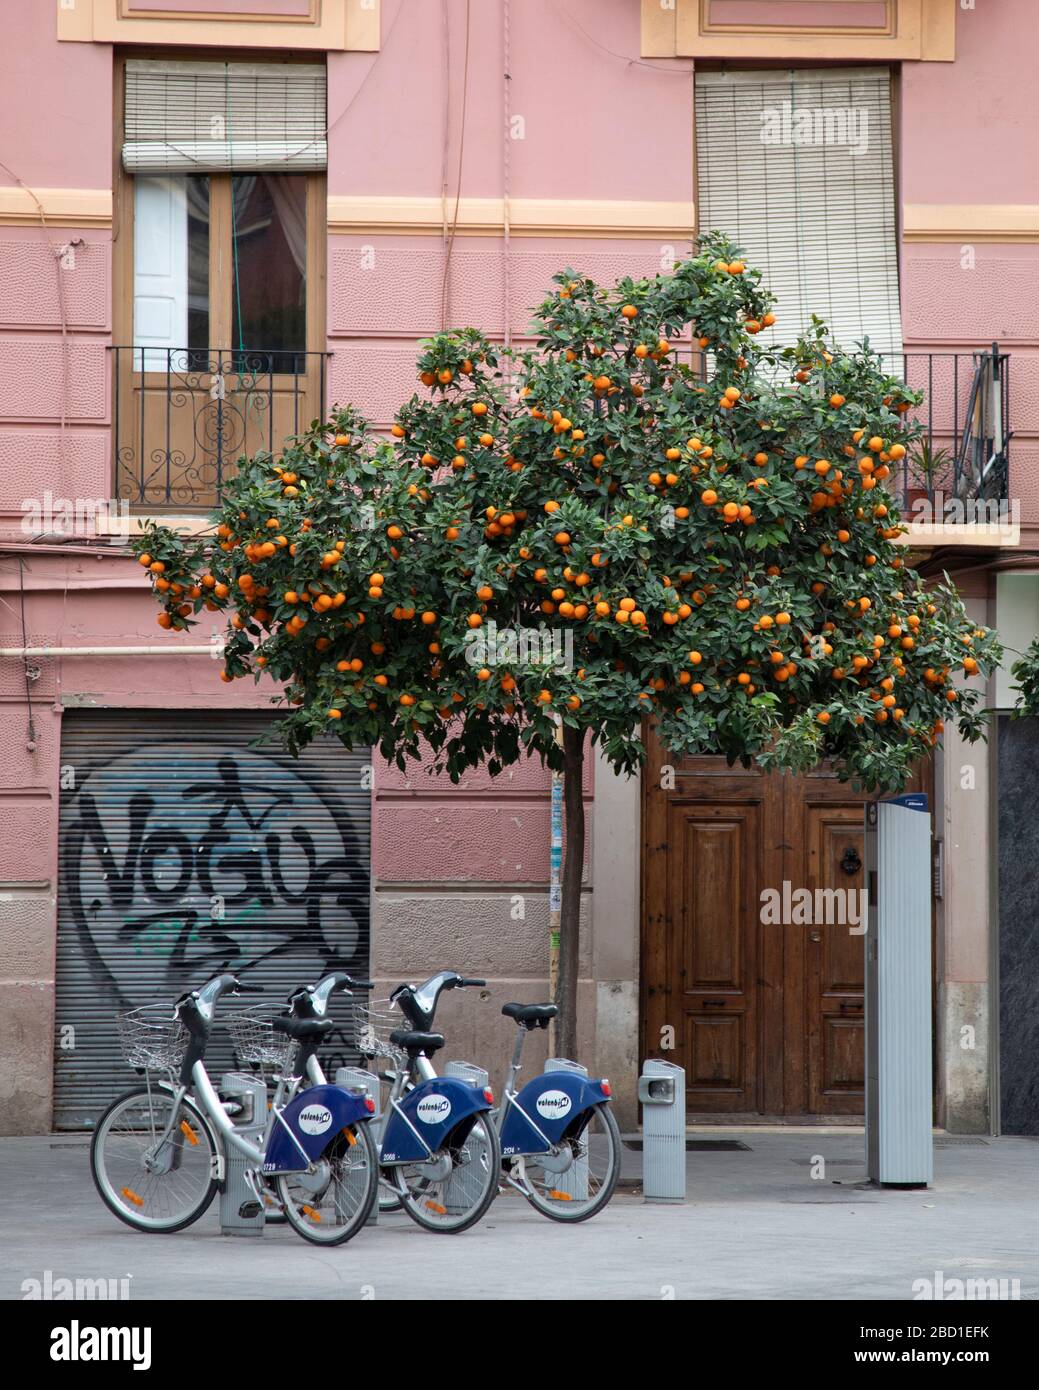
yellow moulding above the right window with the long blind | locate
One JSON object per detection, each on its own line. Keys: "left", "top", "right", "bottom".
{"left": 641, "top": 0, "right": 957, "bottom": 63}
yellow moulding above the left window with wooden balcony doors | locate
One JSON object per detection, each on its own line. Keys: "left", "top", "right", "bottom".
{"left": 54, "top": 0, "right": 380, "bottom": 53}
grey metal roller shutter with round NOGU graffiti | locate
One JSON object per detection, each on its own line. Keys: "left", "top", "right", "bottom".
{"left": 54, "top": 710, "right": 371, "bottom": 1129}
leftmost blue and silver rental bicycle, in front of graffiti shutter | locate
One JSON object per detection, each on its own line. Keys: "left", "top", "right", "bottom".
{"left": 90, "top": 974, "right": 378, "bottom": 1245}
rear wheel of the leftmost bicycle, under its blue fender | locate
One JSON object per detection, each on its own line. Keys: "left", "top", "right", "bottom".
{"left": 278, "top": 1123, "right": 378, "bottom": 1245}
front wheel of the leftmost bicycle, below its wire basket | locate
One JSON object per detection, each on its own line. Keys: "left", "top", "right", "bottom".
{"left": 90, "top": 1086, "right": 218, "bottom": 1233}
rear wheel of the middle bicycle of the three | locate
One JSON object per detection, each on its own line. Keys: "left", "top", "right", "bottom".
{"left": 389, "top": 1113, "right": 502, "bottom": 1234}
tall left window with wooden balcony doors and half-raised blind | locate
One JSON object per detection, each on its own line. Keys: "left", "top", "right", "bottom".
{"left": 113, "top": 58, "right": 327, "bottom": 509}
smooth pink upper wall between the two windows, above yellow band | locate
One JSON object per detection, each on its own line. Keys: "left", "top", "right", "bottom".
{"left": 328, "top": 0, "right": 693, "bottom": 200}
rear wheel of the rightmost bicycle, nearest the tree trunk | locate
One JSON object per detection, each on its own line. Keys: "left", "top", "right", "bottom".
{"left": 520, "top": 1105, "right": 620, "bottom": 1222}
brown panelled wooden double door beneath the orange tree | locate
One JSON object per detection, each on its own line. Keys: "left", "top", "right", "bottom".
{"left": 641, "top": 742, "right": 928, "bottom": 1119}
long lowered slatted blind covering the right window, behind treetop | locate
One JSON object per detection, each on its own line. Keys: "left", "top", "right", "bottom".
{"left": 695, "top": 68, "right": 901, "bottom": 353}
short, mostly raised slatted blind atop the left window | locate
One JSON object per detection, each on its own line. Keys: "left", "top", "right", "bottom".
{"left": 122, "top": 58, "right": 328, "bottom": 174}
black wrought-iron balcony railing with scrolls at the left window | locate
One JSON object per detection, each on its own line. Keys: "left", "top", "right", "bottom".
{"left": 111, "top": 348, "right": 328, "bottom": 512}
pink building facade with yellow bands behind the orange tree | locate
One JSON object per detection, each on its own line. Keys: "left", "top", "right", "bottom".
{"left": 0, "top": 0, "right": 1039, "bottom": 1133}
